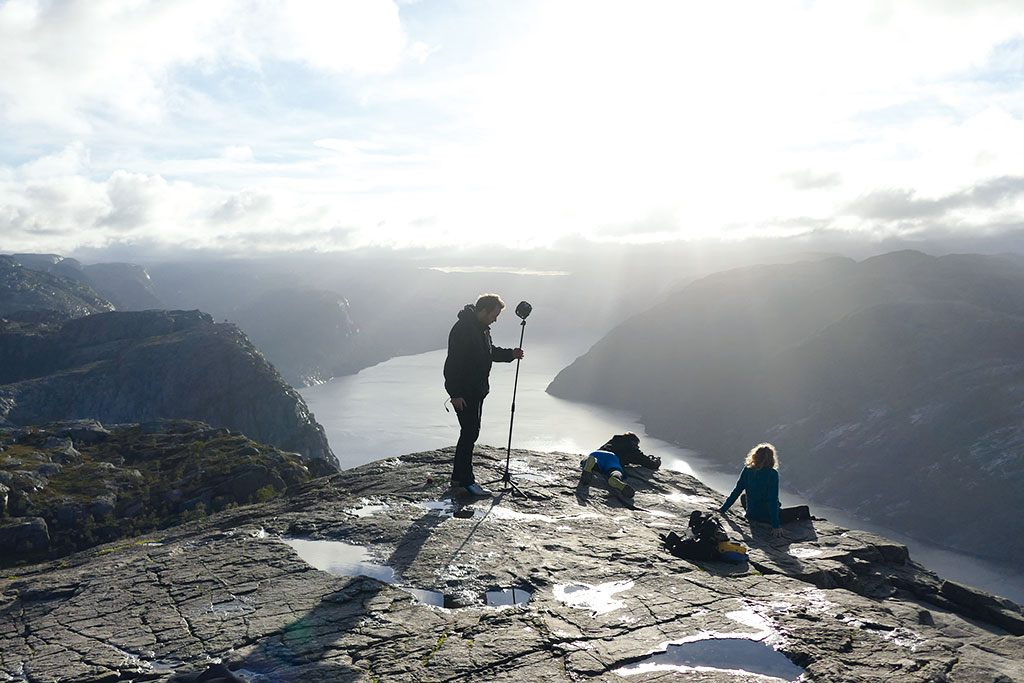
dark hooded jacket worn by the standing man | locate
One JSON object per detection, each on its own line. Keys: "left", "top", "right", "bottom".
{"left": 444, "top": 304, "right": 514, "bottom": 400}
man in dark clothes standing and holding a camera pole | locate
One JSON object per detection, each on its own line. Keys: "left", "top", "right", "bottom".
{"left": 444, "top": 294, "right": 522, "bottom": 496}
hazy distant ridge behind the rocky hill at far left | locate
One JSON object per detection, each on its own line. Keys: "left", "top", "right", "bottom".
{"left": 11, "top": 254, "right": 165, "bottom": 310}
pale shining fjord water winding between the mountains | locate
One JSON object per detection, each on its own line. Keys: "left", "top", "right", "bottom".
{"left": 301, "top": 335, "right": 1024, "bottom": 602}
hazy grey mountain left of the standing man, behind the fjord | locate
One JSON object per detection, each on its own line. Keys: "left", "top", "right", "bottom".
{"left": 232, "top": 289, "right": 364, "bottom": 385}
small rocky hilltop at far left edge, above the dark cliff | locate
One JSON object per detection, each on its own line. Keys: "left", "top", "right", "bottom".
{"left": 0, "top": 255, "right": 114, "bottom": 317}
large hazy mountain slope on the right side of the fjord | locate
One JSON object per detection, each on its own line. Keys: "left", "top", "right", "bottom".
{"left": 548, "top": 252, "right": 1024, "bottom": 562}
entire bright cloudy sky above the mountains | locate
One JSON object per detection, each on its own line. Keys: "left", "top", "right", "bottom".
{"left": 0, "top": 0, "right": 1024, "bottom": 255}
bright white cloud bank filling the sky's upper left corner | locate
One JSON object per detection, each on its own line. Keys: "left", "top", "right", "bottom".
{"left": 0, "top": 0, "right": 415, "bottom": 127}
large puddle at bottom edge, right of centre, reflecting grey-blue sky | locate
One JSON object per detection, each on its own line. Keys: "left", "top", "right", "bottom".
{"left": 615, "top": 638, "right": 804, "bottom": 681}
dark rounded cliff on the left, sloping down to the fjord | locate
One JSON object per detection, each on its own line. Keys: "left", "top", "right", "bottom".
{"left": 0, "top": 310, "right": 338, "bottom": 474}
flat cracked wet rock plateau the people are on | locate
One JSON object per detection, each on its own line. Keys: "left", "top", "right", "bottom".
{"left": 0, "top": 446, "right": 1024, "bottom": 683}
